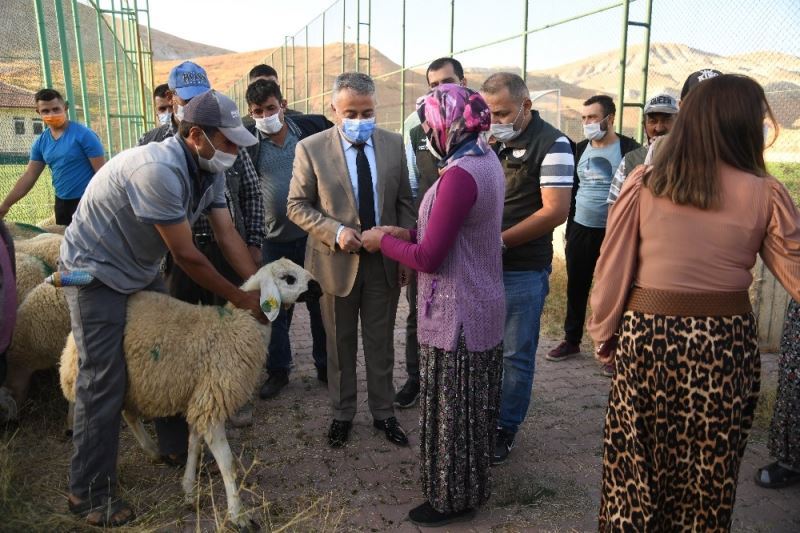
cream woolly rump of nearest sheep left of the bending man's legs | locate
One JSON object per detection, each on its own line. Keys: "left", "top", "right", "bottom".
{"left": 6, "top": 283, "right": 71, "bottom": 372}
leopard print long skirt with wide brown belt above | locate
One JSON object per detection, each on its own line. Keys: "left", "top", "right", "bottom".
{"left": 599, "top": 311, "right": 761, "bottom": 532}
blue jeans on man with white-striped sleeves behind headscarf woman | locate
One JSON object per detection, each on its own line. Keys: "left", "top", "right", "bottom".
{"left": 497, "top": 266, "right": 551, "bottom": 434}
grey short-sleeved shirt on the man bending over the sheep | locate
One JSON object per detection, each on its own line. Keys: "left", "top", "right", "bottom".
{"left": 61, "top": 133, "right": 226, "bottom": 294}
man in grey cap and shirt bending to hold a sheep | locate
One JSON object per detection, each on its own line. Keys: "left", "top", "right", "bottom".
{"left": 61, "top": 91, "right": 264, "bottom": 527}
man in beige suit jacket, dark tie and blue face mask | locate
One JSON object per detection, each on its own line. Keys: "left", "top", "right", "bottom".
{"left": 286, "top": 72, "right": 415, "bottom": 448}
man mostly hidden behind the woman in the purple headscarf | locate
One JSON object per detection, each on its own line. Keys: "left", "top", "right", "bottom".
{"left": 394, "top": 57, "right": 467, "bottom": 408}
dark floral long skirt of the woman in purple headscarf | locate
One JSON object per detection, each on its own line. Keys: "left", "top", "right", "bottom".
{"left": 420, "top": 334, "right": 503, "bottom": 513}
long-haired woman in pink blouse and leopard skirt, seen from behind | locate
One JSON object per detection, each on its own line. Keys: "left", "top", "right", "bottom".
{"left": 588, "top": 75, "right": 800, "bottom": 531}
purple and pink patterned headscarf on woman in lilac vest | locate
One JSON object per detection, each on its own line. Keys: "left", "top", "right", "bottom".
{"left": 417, "top": 83, "right": 492, "bottom": 167}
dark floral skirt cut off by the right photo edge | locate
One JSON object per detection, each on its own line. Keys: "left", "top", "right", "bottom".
{"left": 769, "top": 300, "right": 800, "bottom": 471}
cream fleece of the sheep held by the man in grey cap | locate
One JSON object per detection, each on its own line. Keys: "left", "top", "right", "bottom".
{"left": 60, "top": 292, "right": 268, "bottom": 433}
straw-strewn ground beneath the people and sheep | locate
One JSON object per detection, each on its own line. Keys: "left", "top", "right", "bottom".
{"left": 0, "top": 298, "right": 800, "bottom": 532}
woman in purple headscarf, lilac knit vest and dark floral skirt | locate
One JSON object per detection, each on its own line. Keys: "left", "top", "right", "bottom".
{"left": 361, "top": 84, "right": 505, "bottom": 527}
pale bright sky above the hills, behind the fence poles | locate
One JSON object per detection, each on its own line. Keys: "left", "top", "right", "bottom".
{"left": 150, "top": 0, "right": 800, "bottom": 70}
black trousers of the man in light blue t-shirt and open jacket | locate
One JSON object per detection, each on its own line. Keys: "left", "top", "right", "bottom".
{"left": 564, "top": 220, "right": 606, "bottom": 345}
